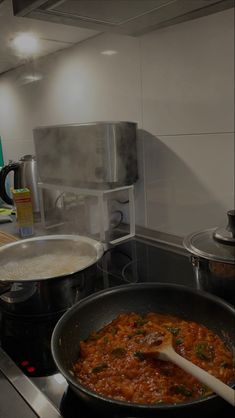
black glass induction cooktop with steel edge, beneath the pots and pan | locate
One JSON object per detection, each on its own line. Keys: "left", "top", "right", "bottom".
{"left": 0, "top": 238, "right": 233, "bottom": 418}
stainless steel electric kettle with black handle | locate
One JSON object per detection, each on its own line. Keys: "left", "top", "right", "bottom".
{"left": 0, "top": 155, "right": 39, "bottom": 212}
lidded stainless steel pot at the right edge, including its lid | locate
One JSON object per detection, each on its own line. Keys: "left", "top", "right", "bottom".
{"left": 184, "top": 210, "right": 235, "bottom": 305}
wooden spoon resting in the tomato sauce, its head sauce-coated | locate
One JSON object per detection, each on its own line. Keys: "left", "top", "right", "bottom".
{"left": 141, "top": 327, "right": 235, "bottom": 406}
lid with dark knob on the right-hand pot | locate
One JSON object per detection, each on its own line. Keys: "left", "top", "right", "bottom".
{"left": 183, "top": 210, "right": 235, "bottom": 264}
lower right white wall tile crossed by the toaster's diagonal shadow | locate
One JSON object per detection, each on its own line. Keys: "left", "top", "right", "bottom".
{"left": 144, "top": 134, "right": 234, "bottom": 235}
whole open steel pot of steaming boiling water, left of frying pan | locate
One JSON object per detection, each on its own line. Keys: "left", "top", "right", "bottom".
{"left": 0, "top": 235, "right": 104, "bottom": 316}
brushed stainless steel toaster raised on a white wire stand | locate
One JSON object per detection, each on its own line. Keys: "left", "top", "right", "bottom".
{"left": 33, "top": 122, "right": 138, "bottom": 188}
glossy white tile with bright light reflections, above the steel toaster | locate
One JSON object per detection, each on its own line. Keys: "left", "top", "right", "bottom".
{"left": 0, "top": 34, "right": 141, "bottom": 142}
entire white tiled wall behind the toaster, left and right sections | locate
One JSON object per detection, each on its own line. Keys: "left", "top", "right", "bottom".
{"left": 0, "top": 9, "right": 234, "bottom": 235}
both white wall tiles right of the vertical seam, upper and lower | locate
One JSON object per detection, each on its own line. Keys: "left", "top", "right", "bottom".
{"left": 137, "top": 9, "right": 234, "bottom": 236}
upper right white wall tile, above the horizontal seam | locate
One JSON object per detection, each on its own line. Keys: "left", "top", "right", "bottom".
{"left": 141, "top": 9, "right": 234, "bottom": 135}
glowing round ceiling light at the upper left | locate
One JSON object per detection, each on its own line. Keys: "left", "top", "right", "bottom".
{"left": 12, "top": 33, "right": 39, "bottom": 56}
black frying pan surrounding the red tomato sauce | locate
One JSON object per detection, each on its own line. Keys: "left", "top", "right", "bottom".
{"left": 52, "top": 283, "right": 235, "bottom": 417}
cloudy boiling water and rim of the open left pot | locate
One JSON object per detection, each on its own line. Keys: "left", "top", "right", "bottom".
{"left": 0, "top": 235, "right": 103, "bottom": 282}
